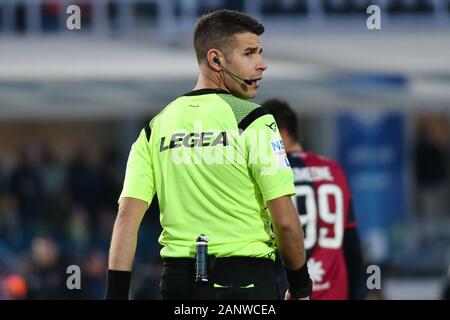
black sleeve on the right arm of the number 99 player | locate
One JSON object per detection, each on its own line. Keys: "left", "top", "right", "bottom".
{"left": 343, "top": 205, "right": 365, "bottom": 300}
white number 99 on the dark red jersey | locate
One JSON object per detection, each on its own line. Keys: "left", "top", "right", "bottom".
{"left": 292, "top": 184, "right": 344, "bottom": 250}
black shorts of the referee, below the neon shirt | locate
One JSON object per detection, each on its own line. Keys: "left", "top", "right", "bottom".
{"left": 160, "top": 257, "right": 279, "bottom": 300}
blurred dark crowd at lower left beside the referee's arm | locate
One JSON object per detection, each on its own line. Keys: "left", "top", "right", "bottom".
{"left": 0, "top": 145, "right": 160, "bottom": 300}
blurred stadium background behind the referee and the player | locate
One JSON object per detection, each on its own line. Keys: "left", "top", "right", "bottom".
{"left": 0, "top": 0, "right": 450, "bottom": 299}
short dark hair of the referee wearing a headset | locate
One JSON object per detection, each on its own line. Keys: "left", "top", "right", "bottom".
{"left": 194, "top": 9, "right": 264, "bottom": 64}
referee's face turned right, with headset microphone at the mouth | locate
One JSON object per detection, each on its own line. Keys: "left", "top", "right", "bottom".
{"left": 225, "top": 32, "right": 267, "bottom": 99}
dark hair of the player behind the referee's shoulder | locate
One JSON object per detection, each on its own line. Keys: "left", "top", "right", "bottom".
{"left": 261, "top": 99, "right": 298, "bottom": 139}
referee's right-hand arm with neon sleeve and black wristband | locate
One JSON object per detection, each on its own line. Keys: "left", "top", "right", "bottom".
{"left": 243, "top": 113, "right": 312, "bottom": 299}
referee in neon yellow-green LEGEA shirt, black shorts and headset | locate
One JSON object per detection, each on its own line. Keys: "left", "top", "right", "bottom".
{"left": 106, "top": 10, "right": 311, "bottom": 299}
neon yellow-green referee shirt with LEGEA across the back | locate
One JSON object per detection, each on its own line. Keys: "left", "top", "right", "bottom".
{"left": 120, "top": 89, "right": 295, "bottom": 258}
